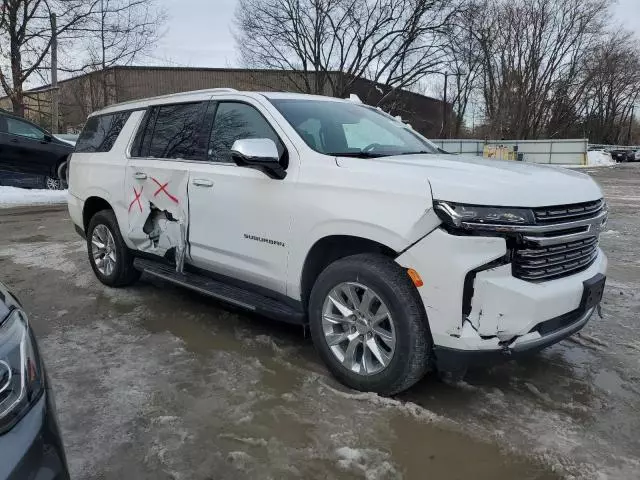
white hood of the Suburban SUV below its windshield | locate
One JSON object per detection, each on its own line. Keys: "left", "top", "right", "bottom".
{"left": 337, "top": 155, "right": 603, "bottom": 207}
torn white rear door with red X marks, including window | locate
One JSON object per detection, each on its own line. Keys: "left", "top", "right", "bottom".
{"left": 125, "top": 102, "right": 207, "bottom": 264}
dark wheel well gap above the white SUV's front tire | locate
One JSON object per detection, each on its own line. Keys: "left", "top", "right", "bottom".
{"left": 300, "top": 235, "right": 398, "bottom": 308}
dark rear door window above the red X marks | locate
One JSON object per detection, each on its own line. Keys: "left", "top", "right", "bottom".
{"left": 148, "top": 102, "right": 206, "bottom": 160}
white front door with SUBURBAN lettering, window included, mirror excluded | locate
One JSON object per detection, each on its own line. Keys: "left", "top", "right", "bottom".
{"left": 189, "top": 98, "right": 297, "bottom": 293}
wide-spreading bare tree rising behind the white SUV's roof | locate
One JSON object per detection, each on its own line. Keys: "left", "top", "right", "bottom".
{"left": 236, "top": 0, "right": 459, "bottom": 103}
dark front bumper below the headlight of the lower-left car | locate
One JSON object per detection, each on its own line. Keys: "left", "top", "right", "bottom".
{"left": 0, "top": 391, "right": 69, "bottom": 480}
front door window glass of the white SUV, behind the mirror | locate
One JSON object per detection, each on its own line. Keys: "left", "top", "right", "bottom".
{"left": 207, "top": 102, "right": 284, "bottom": 162}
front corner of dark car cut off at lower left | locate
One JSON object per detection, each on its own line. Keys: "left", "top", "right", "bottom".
{"left": 0, "top": 283, "right": 69, "bottom": 480}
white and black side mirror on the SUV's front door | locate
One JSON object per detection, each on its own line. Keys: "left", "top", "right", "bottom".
{"left": 231, "top": 138, "right": 287, "bottom": 180}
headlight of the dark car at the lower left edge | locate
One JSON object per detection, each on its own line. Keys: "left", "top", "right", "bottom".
{"left": 0, "top": 309, "right": 44, "bottom": 433}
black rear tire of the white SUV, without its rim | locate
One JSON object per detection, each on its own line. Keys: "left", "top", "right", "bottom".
{"left": 87, "top": 210, "right": 141, "bottom": 287}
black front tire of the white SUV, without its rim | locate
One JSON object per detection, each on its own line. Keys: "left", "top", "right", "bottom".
{"left": 309, "top": 253, "right": 432, "bottom": 395}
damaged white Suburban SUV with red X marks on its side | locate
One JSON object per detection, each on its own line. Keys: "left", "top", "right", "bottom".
{"left": 69, "top": 89, "right": 607, "bottom": 394}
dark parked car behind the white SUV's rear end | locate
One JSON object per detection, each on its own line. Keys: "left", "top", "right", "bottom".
{"left": 0, "top": 111, "right": 74, "bottom": 190}
